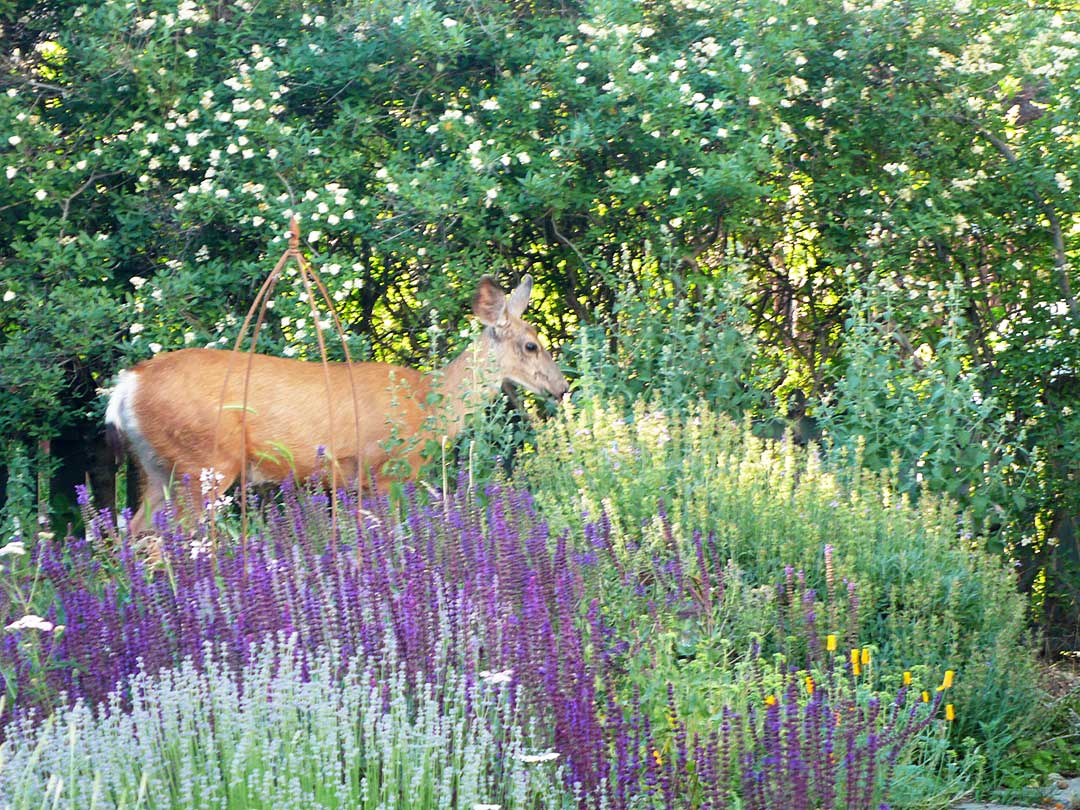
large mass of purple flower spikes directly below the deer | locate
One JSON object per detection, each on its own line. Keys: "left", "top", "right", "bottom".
{"left": 0, "top": 485, "right": 607, "bottom": 789}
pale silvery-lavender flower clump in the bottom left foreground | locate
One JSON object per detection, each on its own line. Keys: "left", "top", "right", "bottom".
{"left": 0, "top": 633, "right": 576, "bottom": 810}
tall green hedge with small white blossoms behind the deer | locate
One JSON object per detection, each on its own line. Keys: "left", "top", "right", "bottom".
{"left": 0, "top": 0, "right": 1080, "bottom": 644}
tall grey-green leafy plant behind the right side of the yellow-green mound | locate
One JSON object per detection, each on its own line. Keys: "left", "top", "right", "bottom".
{"left": 818, "top": 282, "right": 1024, "bottom": 529}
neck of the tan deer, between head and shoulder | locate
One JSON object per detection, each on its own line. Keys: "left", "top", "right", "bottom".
{"left": 428, "top": 329, "right": 502, "bottom": 440}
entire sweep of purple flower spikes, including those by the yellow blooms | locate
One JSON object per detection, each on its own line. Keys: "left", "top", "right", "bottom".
{"left": 0, "top": 484, "right": 940, "bottom": 810}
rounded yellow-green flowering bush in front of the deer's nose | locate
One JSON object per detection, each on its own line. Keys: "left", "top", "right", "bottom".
{"left": 524, "top": 400, "right": 1036, "bottom": 768}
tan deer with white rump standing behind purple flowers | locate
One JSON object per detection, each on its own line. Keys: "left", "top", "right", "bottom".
{"left": 105, "top": 274, "right": 569, "bottom": 536}
